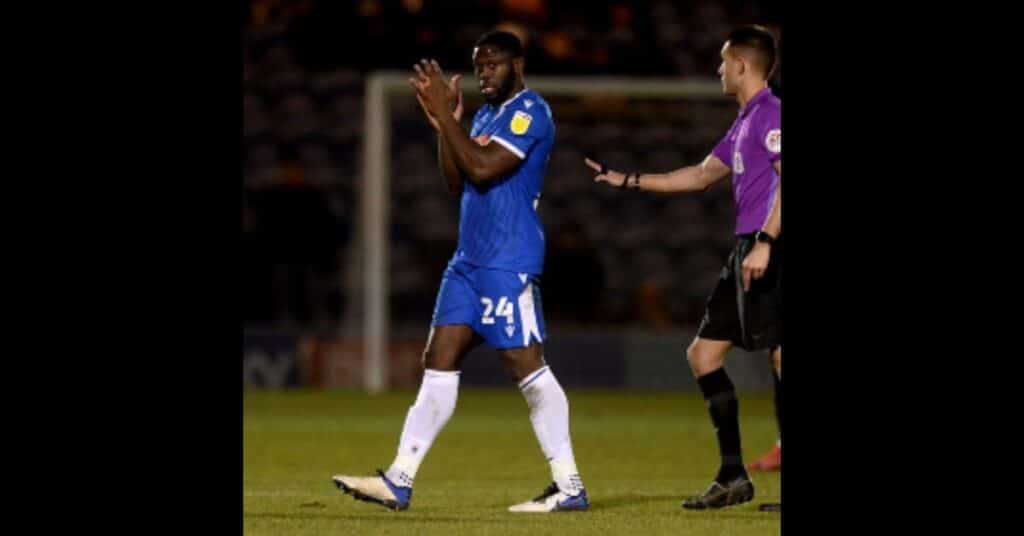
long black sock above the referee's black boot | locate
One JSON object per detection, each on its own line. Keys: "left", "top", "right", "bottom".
{"left": 697, "top": 368, "right": 746, "bottom": 484}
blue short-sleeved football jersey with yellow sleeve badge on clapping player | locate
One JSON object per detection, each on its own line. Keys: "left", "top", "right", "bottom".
{"left": 452, "top": 88, "right": 555, "bottom": 275}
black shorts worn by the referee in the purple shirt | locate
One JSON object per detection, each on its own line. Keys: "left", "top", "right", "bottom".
{"left": 697, "top": 234, "right": 782, "bottom": 352}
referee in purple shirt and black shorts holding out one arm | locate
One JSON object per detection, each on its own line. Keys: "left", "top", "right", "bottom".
{"left": 586, "top": 26, "right": 782, "bottom": 509}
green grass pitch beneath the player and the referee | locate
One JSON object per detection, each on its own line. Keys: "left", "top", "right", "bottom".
{"left": 244, "top": 387, "right": 779, "bottom": 536}
